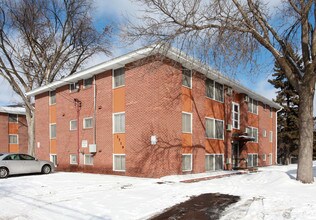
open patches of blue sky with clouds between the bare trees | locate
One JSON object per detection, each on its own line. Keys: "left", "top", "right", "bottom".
{"left": 0, "top": 0, "right": 312, "bottom": 111}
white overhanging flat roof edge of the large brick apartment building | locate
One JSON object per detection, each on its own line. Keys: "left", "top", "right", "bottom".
{"left": 26, "top": 45, "right": 281, "bottom": 109}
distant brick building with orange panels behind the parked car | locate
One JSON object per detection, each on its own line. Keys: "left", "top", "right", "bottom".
{"left": 0, "top": 106, "right": 28, "bottom": 153}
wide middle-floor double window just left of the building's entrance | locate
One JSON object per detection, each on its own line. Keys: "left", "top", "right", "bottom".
{"left": 205, "top": 118, "right": 224, "bottom": 140}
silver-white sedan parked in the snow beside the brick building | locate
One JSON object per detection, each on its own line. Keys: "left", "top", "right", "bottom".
{"left": 0, "top": 153, "right": 55, "bottom": 178}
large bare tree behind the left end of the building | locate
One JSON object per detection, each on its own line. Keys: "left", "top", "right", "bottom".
{"left": 0, "top": 0, "right": 110, "bottom": 157}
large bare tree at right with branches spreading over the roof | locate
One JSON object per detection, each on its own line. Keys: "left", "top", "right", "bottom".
{"left": 125, "top": 0, "right": 316, "bottom": 183}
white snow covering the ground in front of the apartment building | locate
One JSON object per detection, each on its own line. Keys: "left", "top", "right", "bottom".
{"left": 0, "top": 161, "right": 316, "bottom": 220}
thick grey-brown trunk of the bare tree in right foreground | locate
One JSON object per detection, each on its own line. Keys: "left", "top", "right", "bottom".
{"left": 297, "top": 86, "right": 314, "bottom": 183}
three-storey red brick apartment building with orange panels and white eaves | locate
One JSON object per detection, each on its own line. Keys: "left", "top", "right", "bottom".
{"left": 27, "top": 45, "right": 280, "bottom": 177}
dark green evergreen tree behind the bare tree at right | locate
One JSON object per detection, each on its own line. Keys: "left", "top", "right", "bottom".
{"left": 269, "top": 60, "right": 299, "bottom": 164}
